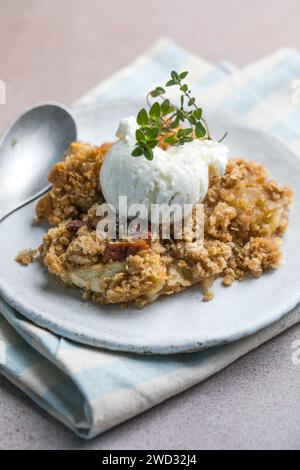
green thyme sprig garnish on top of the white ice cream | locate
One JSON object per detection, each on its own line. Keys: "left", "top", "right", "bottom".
{"left": 132, "top": 71, "right": 224, "bottom": 160}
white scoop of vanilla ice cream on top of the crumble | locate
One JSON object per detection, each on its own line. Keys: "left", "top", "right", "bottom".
{"left": 100, "top": 117, "right": 228, "bottom": 216}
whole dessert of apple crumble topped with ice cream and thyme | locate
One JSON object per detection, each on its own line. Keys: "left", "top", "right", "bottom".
{"left": 19, "top": 72, "right": 292, "bottom": 307}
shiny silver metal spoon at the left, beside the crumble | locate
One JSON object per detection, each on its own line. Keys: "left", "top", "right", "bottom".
{"left": 0, "top": 103, "right": 77, "bottom": 222}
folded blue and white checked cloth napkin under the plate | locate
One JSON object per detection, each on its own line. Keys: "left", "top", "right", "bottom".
{"left": 0, "top": 39, "right": 300, "bottom": 439}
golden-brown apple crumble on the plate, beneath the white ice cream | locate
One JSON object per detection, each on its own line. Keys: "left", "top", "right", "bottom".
{"left": 31, "top": 142, "right": 292, "bottom": 307}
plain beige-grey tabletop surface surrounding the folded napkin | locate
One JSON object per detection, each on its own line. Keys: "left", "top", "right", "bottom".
{"left": 0, "top": 0, "right": 300, "bottom": 449}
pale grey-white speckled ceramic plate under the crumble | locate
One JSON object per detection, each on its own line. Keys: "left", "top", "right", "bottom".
{"left": 0, "top": 102, "right": 300, "bottom": 354}
